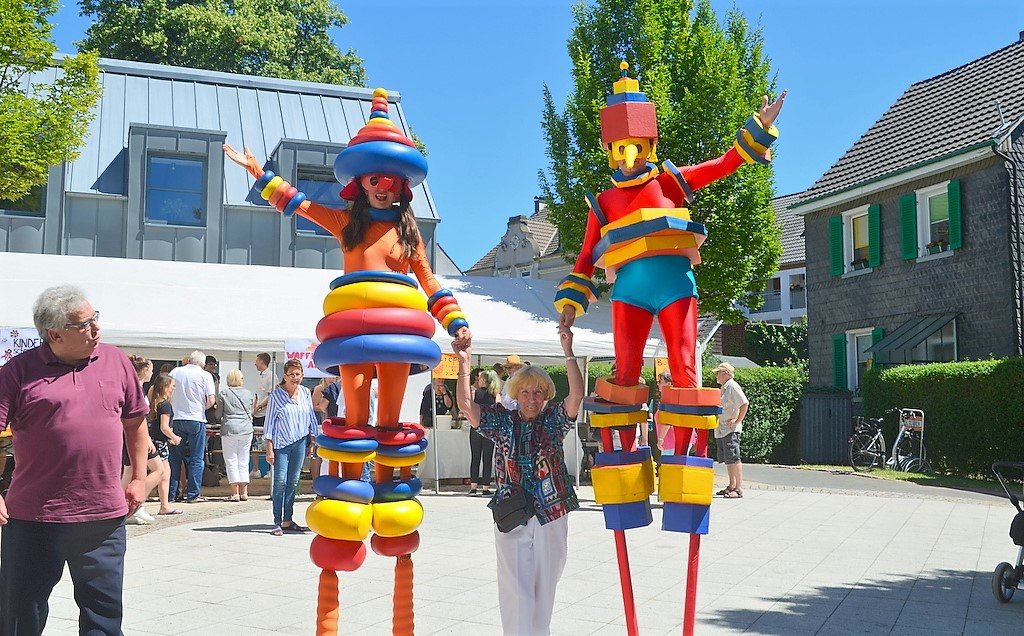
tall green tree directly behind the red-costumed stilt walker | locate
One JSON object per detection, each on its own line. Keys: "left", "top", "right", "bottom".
{"left": 540, "top": 0, "right": 781, "bottom": 322}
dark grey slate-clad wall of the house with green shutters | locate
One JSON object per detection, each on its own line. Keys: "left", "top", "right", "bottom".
{"left": 805, "top": 157, "right": 1017, "bottom": 385}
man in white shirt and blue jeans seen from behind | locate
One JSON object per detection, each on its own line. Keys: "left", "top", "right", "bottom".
{"left": 169, "top": 351, "right": 217, "bottom": 504}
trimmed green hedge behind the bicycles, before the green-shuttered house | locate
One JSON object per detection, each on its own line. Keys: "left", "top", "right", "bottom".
{"left": 860, "top": 357, "right": 1024, "bottom": 475}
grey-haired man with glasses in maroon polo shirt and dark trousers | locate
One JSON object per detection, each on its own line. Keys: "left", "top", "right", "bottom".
{"left": 0, "top": 286, "right": 150, "bottom": 636}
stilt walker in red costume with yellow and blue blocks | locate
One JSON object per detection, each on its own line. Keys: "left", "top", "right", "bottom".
{"left": 555, "top": 61, "right": 785, "bottom": 635}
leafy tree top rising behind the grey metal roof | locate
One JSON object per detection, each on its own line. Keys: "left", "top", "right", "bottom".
{"left": 78, "top": 0, "right": 367, "bottom": 86}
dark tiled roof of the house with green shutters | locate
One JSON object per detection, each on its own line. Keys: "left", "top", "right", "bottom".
{"left": 798, "top": 36, "right": 1024, "bottom": 207}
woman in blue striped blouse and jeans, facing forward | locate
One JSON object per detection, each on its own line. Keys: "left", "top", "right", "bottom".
{"left": 263, "top": 359, "right": 319, "bottom": 537}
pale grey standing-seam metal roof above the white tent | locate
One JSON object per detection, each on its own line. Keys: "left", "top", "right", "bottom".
{"left": 27, "top": 58, "right": 438, "bottom": 219}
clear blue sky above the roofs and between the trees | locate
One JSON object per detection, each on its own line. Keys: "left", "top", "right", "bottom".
{"left": 54, "top": 0, "right": 1024, "bottom": 268}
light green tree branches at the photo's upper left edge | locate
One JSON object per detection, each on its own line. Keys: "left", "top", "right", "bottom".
{"left": 0, "top": 0, "right": 99, "bottom": 201}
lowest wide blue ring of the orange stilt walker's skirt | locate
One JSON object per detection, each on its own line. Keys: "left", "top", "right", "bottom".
{"left": 313, "top": 334, "right": 441, "bottom": 376}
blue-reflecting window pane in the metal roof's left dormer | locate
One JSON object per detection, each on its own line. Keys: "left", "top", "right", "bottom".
{"left": 145, "top": 155, "right": 206, "bottom": 226}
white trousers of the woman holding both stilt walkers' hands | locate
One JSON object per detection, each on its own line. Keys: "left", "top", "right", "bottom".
{"left": 495, "top": 514, "right": 569, "bottom": 636}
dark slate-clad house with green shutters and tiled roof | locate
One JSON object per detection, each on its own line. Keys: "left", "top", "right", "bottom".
{"left": 791, "top": 34, "right": 1024, "bottom": 391}
